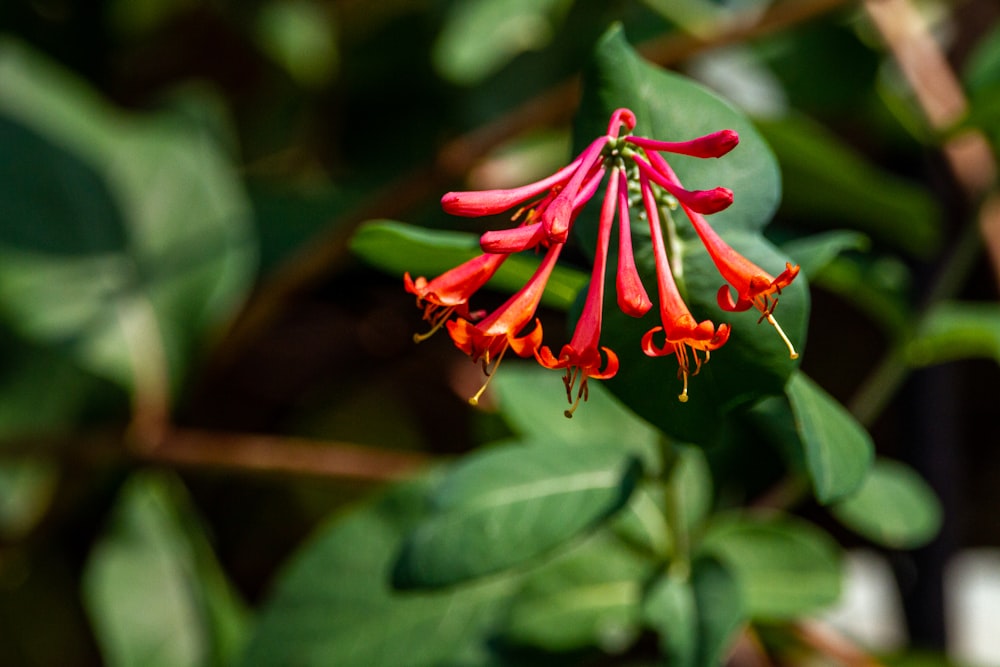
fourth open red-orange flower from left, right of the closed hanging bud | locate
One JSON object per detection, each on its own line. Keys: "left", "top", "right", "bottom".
{"left": 639, "top": 173, "right": 729, "bottom": 403}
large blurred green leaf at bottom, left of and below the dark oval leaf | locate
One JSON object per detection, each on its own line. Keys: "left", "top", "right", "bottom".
{"left": 237, "top": 478, "right": 519, "bottom": 667}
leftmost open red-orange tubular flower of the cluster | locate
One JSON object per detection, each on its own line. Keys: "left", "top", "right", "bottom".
{"left": 403, "top": 253, "right": 508, "bottom": 343}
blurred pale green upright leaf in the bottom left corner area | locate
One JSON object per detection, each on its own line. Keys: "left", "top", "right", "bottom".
{"left": 83, "top": 473, "right": 248, "bottom": 667}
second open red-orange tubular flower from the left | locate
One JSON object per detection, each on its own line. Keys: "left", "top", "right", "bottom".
{"left": 447, "top": 244, "right": 562, "bottom": 405}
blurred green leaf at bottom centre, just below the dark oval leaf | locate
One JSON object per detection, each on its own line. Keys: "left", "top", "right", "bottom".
{"left": 504, "top": 532, "right": 654, "bottom": 653}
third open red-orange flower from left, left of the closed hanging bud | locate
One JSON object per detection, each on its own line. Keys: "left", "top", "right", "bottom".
{"left": 535, "top": 167, "right": 620, "bottom": 417}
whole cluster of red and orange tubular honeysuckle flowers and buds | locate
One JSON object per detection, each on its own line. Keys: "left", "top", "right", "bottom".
{"left": 404, "top": 109, "right": 799, "bottom": 416}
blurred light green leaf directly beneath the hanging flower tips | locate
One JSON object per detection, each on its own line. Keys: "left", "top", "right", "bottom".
{"left": 491, "top": 362, "right": 663, "bottom": 474}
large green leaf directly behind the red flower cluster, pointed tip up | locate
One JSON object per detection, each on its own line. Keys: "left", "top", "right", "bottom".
{"left": 575, "top": 27, "right": 808, "bottom": 444}
